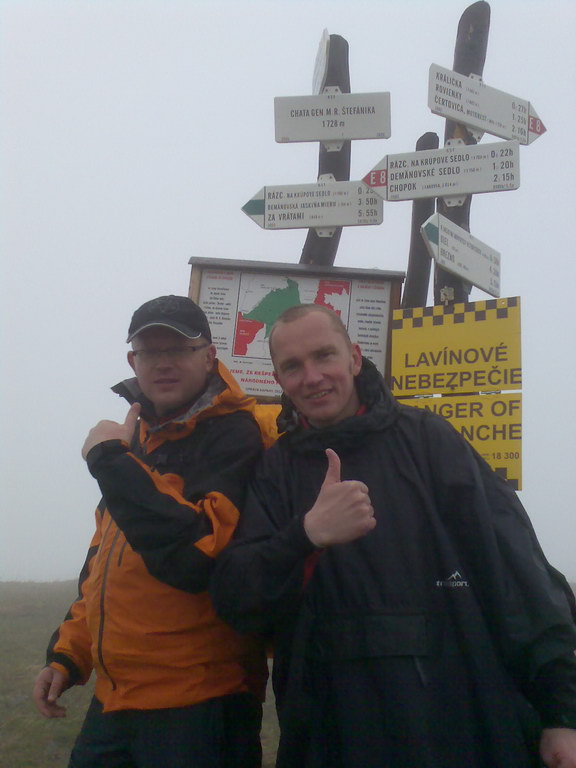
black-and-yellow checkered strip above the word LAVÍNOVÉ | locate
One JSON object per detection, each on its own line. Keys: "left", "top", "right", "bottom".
{"left": 392, "top": 296, "right": 520, "bottom": 331}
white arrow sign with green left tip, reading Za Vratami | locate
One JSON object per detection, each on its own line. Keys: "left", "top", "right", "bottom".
{"left": 242, "top": 181, "right": 383, "bottom": 229}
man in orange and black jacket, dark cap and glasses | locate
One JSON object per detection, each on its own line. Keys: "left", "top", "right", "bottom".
{"left": 34, "top": 296, "right": 266, "bottom": 768}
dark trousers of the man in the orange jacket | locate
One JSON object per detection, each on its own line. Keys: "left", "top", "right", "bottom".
{"left": 68, "top": 693, "right": 262, "bottom": 768}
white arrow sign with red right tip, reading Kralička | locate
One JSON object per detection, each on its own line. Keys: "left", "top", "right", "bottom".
{"left": 428, "top": 64, "right": 546, "bottom": 144}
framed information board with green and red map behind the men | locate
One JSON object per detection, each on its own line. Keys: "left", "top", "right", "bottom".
{"left": 189, "top": 258, "right": 404, "bottom": 398}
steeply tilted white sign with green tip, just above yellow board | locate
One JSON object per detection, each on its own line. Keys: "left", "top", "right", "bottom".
{"left": 420, "top": 213, "right": 500, "bottom": 298}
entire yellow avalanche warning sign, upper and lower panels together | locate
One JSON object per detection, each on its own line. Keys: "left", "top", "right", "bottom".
{"left": 391, "top": 297, "right": 522, "bottom": 489}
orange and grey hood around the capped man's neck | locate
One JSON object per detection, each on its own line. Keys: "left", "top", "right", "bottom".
{"left": 112, "top": 360, "right": 256, "bottom": 438}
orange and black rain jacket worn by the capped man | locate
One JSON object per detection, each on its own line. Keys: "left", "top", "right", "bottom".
{"left": 47, "top": 362, "right": 268, "bottom": 711}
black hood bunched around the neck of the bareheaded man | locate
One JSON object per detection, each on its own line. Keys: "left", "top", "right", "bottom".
{"left": 277, "top": 357, "right": 399, "bottom": 452}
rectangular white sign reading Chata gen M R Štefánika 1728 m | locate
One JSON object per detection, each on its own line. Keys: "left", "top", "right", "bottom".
{"left": 274, "top": 93, "right": 390, "bottom": 143}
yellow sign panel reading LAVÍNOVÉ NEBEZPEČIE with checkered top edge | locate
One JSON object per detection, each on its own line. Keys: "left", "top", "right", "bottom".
{"left": 391, "top": 297, "right": 522, "bottom": 397}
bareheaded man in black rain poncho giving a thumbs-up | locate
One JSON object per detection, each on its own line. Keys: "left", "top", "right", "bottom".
{"left": 213, "top": 305, "right": 576, "bottom": 768}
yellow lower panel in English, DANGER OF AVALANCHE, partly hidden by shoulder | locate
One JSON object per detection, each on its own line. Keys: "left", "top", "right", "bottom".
{"left": 399, "top": 392, "right": 522, "bottom": 490}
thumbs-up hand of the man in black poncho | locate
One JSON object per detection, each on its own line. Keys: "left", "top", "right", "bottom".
{"left": 304, "top": 448, "right": 376, "bottom": 547}
